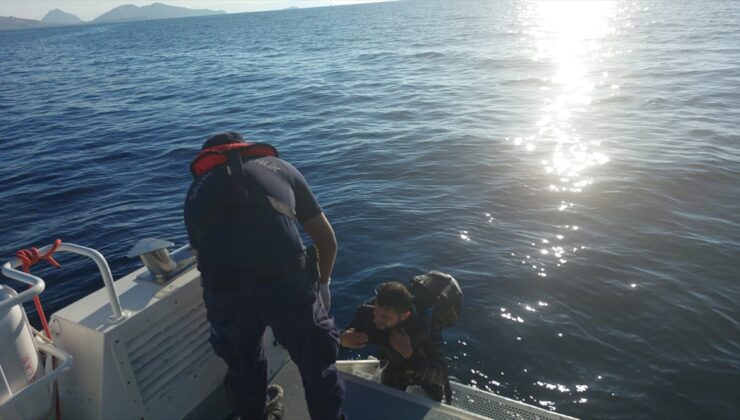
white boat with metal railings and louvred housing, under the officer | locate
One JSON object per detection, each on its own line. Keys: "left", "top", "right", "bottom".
{"left": 0, "top": 238, "right": 573, "bottom": 420}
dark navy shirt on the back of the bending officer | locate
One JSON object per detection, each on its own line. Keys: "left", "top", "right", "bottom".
{"left": 184, "top": 157, "right": 321, "bottom": 268}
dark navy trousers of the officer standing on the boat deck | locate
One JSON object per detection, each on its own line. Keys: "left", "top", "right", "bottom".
{"left": 200, "top": 267, "right": 345, "bottom": 420}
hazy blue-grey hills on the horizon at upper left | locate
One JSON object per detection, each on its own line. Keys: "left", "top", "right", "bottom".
{"left": 0, "top": 3, "right": 226, "bottom": 31}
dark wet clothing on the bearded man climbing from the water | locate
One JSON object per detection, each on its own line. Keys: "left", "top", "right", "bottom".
{"left": 347, "top": 298, "right": 449, "bottom": 401}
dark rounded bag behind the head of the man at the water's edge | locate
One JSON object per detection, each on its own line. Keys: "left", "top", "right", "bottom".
{"left": 409, "top": 271, "right": 463, "bottom": 328}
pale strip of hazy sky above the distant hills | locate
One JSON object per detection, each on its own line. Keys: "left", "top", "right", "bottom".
{"left": 0, "top": 0, "right": 394, "bottom": 20}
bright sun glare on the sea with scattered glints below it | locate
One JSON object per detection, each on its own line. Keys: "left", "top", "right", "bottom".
{"left": 498, "top": 10, "right": 620, "bottom": 410}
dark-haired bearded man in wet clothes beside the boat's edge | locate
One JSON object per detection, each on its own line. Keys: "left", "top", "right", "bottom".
{"left": 340, "top": 282, "right": 450, "bottom": 402}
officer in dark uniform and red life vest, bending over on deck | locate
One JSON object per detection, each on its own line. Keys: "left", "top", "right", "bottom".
{"left": 185, "top": 132, "right": 344, "bottom": 419}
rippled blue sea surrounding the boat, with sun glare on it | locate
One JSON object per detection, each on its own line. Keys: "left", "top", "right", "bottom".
{"left": 0, "top": 0, "right": 740, "bottom": 419}
